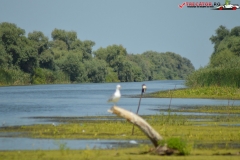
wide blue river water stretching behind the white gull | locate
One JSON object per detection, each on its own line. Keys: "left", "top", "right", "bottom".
{"left": 0, "top": 80, "right": 240, "bottom": 150}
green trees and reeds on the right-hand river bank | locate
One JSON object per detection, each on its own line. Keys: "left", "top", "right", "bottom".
{"left": 186, "top": 26, "right": 240, "bottom": 88}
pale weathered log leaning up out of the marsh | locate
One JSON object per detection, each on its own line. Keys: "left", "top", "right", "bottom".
{"left": 108, "top": 106, "right": 163, "bottom": 147}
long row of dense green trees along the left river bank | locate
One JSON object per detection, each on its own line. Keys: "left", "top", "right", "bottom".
{"left": 0, "top": 22, "right": 195, "bottom": 85}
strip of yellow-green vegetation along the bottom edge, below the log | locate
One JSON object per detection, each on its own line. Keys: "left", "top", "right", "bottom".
{"left": 0, "top": 146, "right": 239, "bottom": 160}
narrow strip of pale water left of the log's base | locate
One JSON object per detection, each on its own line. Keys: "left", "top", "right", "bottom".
{"left": 0, "top": 137, "right": 146, "bottom": 150}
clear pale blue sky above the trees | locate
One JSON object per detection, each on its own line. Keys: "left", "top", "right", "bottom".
{"left": 0, "top": 0, "right": 240, "bottom": 69}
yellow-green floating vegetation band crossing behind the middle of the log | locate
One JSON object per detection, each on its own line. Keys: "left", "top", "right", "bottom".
{"left": 0, "top": 115, "right": 240, "bottom": 142}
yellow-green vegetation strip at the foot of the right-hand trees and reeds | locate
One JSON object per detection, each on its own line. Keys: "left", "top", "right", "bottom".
{"left": 145, "top": 86, "right": 240, "bottom": 99}
